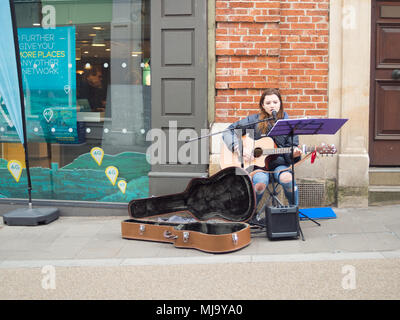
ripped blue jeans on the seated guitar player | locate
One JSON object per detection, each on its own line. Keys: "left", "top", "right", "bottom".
{"left": 253, "top": 166, "right": 299, "bottom": 206}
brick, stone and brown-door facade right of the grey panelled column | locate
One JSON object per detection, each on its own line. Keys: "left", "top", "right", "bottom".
{"left": 208, "top": 0, "right": 400, "bottom": 207}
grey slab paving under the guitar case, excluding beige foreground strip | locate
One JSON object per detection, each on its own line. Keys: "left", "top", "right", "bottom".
{"left": 0, "top": 205, "right": 400, "bottom": 262}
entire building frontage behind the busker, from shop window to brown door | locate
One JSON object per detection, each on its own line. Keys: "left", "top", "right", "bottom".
{"left": 0, "top": 0, "right": 400, "bottom": 214}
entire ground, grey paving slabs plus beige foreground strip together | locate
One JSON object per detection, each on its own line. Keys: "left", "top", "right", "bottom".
{"left": 0, "top": 205, "right": 400, "bottom": 300}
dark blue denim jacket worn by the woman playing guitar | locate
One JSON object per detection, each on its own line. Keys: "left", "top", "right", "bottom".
{"left": 222, "top": 112, "right": 301, "bottom": 170}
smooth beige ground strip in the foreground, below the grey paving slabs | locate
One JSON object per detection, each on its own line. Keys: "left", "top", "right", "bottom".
{"left": 0, "top": 256, "right": 400, "bottom": 300}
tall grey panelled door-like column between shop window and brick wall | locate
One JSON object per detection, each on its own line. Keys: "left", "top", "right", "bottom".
{"left": 149, "top": 0, "right": 209, "bottom": 195}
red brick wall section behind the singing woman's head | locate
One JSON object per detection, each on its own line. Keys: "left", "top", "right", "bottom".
{"left": 215, "top": 0, "right": 329, "bottom": 122}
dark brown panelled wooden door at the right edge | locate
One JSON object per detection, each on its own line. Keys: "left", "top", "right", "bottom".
{"left": 369, "top": 0, "right": 400, "bottom": 166}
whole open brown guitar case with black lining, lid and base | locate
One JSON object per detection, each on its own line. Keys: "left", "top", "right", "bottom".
{"left": 121, "top": 167, "right": 256, "bottom": 253}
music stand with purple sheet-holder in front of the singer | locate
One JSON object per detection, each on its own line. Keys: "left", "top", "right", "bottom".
{"left": 267, "top": 119, "right": 348, "bottom": 241}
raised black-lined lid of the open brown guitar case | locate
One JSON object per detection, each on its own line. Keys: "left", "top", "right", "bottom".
{"left": 128, "top": 167, "right": 256, "bottom": 222}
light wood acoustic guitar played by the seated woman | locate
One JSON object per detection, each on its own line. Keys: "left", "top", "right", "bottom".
{"left": 219, "top": 136, "right": 337, "bottom": 169}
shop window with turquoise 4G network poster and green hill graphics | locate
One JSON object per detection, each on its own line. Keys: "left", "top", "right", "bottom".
{"left": 0, "top": 0, "right": 151, "bottom": 203}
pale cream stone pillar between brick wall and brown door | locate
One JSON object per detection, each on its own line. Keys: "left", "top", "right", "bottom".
{"left": 329, "top": 0, "right": 371, "bottom": 207}
